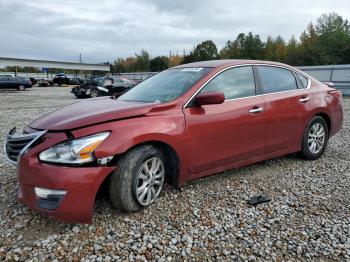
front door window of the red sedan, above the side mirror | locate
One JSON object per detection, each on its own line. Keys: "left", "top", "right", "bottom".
{"left": 200, "top": 66, "right": 255, "bottom": 100}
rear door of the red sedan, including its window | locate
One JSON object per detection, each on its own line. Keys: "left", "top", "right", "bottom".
{"left": 257, "top": 66, "right": 311, "bottom": 154}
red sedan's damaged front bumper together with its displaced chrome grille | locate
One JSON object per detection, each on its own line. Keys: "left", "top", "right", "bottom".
{"left": 4, "top": 131, "right": 115, "bottom": 223}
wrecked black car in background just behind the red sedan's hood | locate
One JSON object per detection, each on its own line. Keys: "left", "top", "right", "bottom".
{"left": 71, "top": 76, "right": 136, "bottom": 98}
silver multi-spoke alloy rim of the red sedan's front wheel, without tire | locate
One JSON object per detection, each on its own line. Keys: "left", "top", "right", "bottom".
{"left": 134, "top": 157, "right": 165, "bottom": 206}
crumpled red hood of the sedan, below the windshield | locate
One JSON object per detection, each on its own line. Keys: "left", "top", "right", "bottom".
{"left": 29, "top": 97, "right": 156, "bottom": 131}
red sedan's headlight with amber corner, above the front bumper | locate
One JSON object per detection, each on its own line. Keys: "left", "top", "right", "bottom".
{"left": 39, "top": 132, "right": 110, "bottom": 164}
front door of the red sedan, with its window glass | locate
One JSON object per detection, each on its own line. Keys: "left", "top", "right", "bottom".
{"left": 184, "top": 66, "right": 265, "bottom": 173}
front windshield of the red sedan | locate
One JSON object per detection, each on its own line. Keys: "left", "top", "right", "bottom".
{"left": 118, "top": 68, "right": 212, "bottom": 103}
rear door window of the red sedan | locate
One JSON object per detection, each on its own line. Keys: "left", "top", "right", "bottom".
{"left": 258, "top": 66, "right": 298, "bottom": 94}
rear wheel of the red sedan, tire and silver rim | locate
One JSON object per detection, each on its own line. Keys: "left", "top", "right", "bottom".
{"left": 300, "top": 116, "right": 329, "bottom": 160}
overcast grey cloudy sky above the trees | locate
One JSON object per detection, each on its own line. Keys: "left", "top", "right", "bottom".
{"left": 0, "top": 0, "right": 350, "bottom": 63}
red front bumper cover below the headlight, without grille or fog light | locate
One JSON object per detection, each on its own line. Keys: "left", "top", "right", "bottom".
{"left": 18, "top": 154, "right": 115, "bottom": 223}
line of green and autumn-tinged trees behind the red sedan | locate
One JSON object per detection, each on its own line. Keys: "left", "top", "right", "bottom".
{"left": 111, "top": 13, "right": 350, "bottom": 73}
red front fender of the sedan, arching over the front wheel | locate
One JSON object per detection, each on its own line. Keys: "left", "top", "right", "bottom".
{"left": 72, "top": 112, "right": 189, "bottom": 185}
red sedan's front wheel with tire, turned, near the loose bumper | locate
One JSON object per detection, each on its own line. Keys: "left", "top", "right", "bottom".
{"left": 109, "top": 145, "right": 166, "bottom": 212}
